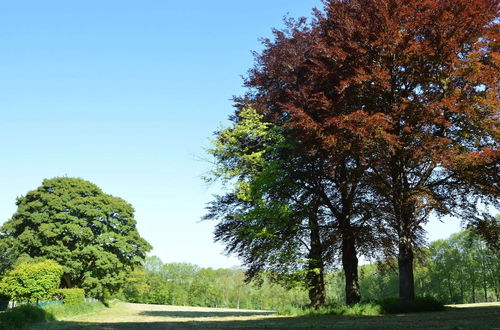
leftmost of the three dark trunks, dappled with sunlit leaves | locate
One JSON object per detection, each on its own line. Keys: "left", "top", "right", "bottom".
{"left": 307, "top": 216, "right": 326, "bottom": 309}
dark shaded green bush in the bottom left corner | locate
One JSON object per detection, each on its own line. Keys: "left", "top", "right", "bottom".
{"left": 0, "top": 305, "right": 55, "bottom": 330}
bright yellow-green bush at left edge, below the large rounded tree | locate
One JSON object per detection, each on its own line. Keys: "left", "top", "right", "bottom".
{"left": 0, "top": 260, "right": 63, "bottom": 302}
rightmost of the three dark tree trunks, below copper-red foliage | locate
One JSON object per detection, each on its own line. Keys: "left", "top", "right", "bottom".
{"left": 398, "top": 235, "right": 415, "bottom": 301}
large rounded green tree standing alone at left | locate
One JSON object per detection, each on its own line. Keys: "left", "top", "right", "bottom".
{"left": 0, "top": 177, "right": 151, "bottom": 298}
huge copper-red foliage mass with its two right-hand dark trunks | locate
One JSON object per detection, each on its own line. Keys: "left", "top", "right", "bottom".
{"left": 237, "top": 0, "right": 500, "bottom": 303}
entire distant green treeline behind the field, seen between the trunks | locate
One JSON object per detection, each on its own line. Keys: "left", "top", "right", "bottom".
{"left": 122, "top": 231, "right": 500, "bottom": 309}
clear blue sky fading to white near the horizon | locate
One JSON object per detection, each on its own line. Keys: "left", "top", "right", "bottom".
{"left": 0, "top": 0, "right": 458, "bottom": 267}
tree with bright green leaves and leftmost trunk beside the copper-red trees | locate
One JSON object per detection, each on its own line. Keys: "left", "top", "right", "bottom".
{"left": 205, "top": 108, "right": 331, "bottom": 308}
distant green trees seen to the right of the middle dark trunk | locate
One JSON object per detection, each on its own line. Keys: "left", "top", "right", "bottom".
{"left": 360, "top": 230, "right": 500, "bottom": 304}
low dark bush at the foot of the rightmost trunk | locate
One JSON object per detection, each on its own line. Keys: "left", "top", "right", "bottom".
{"left": 378, "top": 297, "right": 444, "bottom": 314}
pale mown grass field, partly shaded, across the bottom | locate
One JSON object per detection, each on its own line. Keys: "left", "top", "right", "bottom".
{"left": 30, "top": 303, "right": 500, "bottom": 330}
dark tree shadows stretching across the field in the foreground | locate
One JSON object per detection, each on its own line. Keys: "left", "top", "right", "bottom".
{"left": 32, "top": 306, "right": 500, "bottom": 330}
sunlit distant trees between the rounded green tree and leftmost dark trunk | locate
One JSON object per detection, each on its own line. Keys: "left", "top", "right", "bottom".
{"left": 122, "top": 257, "right": 307, "bottom": 309}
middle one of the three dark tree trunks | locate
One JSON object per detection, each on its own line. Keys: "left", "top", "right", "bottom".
{"left": 342, "top": 229, "right": 361, "bottom": 306}
